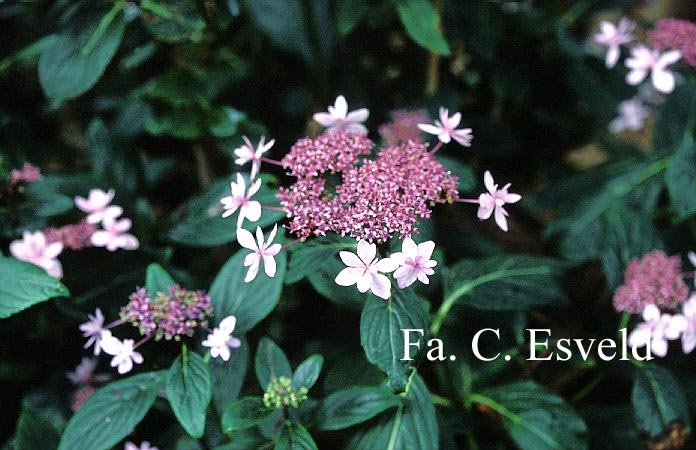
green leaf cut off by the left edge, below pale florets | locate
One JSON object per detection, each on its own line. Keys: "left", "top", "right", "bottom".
{"left": 0, "top": 255, "right": 70, "bottom": 318}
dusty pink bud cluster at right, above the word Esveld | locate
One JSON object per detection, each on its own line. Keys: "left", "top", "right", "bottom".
{"left": 614, "top": 250, "right": 689, "bottom": 314}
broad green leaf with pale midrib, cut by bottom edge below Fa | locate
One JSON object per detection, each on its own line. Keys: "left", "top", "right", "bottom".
{"left": 346, "top": 372, "right": 439, "bottom": 450}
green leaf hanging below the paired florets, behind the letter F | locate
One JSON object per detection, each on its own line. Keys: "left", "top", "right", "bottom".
{"left": 360, "top": 289, "right": 428, "bottom": 388}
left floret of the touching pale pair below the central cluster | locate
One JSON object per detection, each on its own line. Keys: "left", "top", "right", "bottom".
{"left": 335, "top": 240, "right": 399, "bottom": 300}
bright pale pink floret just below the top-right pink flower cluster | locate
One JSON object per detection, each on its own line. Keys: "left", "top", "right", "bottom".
{"left": 626, "top": 45, "right": 681, "bottom": 94}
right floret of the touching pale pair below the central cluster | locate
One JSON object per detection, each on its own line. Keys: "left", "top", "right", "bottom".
{"left": 391, "top": 237, "right": 437, "bottom": 289}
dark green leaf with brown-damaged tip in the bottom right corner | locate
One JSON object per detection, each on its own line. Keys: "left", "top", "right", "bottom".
{"left": 631, "top": 364, "right": 691, "bottom": 437}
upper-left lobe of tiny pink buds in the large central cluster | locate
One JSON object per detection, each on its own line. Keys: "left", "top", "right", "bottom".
{"left": 281, "top": 131, "right": 374, "bottom": 178}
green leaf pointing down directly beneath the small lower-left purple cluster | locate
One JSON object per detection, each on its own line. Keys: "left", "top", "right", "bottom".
{"left": 164, "top": 347, "right": 212, "bottom": 438}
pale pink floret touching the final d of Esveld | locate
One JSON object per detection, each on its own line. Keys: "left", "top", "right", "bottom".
{"left": 628, "top": 305, "right": 687, "bottom": 357}
